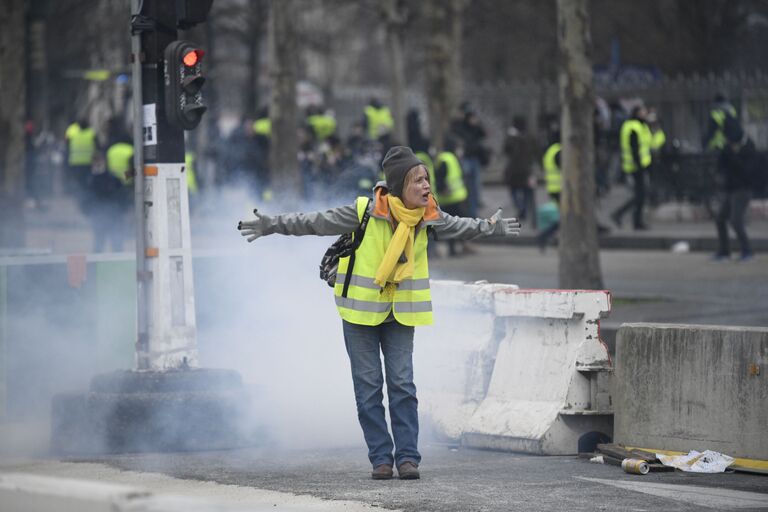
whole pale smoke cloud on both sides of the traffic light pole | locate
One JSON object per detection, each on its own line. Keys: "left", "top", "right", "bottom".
{"left": 0, "top": 174, "right": 492, "bottom": 455}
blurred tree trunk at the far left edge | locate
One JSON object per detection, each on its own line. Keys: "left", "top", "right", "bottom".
{"left": 0, "top": 0, "right": 27, "bottom": 247}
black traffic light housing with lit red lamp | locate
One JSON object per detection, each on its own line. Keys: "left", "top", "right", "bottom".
{"left": 164, "top": 41, "right": 208, "bottom": 130}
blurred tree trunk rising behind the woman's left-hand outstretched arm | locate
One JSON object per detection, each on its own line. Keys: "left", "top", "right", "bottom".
{"left": 269, "top": 0, "right": 301, "bottom": 193}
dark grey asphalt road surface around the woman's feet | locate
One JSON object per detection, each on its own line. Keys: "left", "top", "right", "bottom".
{"left": 52, "top": 443, "right": 768, "bottom": 512}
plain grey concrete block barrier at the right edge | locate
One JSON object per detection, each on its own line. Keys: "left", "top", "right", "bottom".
{"left": 614, "top": 323, "right": 768, "bottom": 460}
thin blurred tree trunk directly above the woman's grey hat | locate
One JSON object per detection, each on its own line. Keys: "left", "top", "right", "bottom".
{"left": 383, "top": 0, "right": 408, "bottom": 144}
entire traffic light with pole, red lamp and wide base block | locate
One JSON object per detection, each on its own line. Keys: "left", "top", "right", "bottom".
{"left": 51, "top": 0, "right": 252, "bottom": 456}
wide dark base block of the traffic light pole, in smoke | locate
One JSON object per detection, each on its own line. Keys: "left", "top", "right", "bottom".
{"left": 51, "top": 369, "right": 257, "bottom": 456}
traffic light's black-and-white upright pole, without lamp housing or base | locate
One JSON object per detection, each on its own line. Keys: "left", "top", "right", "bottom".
{"left": 132, "top": 0, "right": 198, "bottom": 371}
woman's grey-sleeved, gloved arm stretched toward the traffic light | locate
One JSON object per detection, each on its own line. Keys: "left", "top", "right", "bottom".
{"left": 237, "top": 204, "right": 360, "bottom": 242}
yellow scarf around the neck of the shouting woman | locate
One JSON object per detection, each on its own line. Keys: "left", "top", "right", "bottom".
{"left": 374, "top": 195, "right": 424, "bottom": 288}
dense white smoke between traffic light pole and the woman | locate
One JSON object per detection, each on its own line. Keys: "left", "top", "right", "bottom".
{"left": 194, "top": 186, "right": 363, "bottom": 448}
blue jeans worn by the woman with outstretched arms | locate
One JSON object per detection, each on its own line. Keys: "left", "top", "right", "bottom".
{"left": 343, "top": 320, "right": 421, "bottom": 468}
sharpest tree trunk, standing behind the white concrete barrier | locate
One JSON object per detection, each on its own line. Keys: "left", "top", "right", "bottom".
{"left": 557, "top": 0, "right": 603, "bottom": 290}
